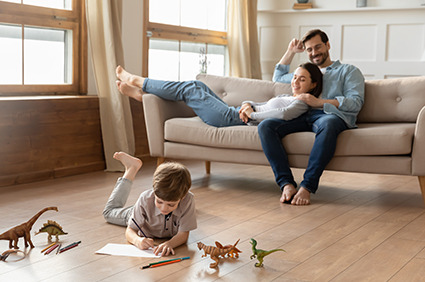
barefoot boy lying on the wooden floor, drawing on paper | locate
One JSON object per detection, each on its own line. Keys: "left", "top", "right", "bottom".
{"left": 103, "top": 152, "right": 197, "bottom": 256}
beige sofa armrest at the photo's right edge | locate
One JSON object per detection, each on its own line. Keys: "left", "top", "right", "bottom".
{"left": 412, "top": 107, "right": 425, "bottom": 176}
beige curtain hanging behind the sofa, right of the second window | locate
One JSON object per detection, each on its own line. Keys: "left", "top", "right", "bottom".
{"left": 227, "top": 0, "right": 261, "bottom": 79}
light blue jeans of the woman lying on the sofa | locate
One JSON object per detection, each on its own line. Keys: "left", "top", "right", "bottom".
{"left": 142, "top": 78, "right": 245, "bottom": 127}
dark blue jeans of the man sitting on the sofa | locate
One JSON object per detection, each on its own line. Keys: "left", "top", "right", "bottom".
{"left": 258, "top": 109, "right": 348, "bottom": 193}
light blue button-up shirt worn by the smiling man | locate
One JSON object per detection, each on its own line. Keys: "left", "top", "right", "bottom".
{"left": 273, "top": 61, "right": 364, "bottom": 128}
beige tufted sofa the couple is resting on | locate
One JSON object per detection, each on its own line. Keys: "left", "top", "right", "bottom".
{"left": 143, "top": 75, "right": 425, "bottom": 202}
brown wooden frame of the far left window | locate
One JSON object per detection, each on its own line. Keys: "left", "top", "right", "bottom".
{"left": 0, "top": 0, "right": 88, "bottom": 96}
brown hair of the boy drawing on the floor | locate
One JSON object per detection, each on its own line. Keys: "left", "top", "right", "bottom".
{"left": 153, "top": 162, "right": 192, "bottom": 202}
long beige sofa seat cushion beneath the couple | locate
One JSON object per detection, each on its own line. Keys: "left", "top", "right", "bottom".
{"left": 165, "top": 117, "right": 415, "bottom": 156}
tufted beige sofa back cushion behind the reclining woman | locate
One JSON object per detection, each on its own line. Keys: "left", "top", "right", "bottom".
{"left": 196, "top": 74, "right": 292, "bottom": 106}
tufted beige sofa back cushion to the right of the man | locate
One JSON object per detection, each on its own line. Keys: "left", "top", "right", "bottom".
{"left": 357, "top": 76, "right": 425, "bottom": 123}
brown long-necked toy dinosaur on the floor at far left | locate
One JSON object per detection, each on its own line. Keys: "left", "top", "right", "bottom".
{"left": 0, "top": 207, "right": 58, "bottom": 249}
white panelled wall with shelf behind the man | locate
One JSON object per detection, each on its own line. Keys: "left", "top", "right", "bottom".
{"left": 258, "top": 0, "right": 425, "bottom": 79}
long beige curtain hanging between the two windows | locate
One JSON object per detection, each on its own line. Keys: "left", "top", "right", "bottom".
{"left": 86, "top": 0, "right": 135, "bottom": 171}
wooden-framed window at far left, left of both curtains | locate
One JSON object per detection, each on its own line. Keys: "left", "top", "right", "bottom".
{"left": 0, "top": 0, "right": 87, "bottom": 95}
